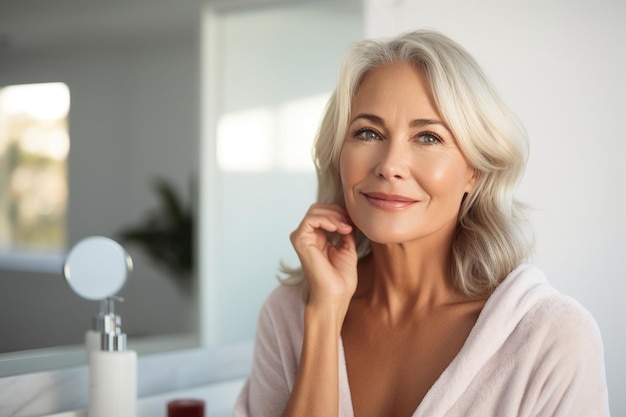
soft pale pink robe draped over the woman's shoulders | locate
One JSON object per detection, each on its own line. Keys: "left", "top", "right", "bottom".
{"left": 234, "top": 265, "right": 609, "bottom": 417}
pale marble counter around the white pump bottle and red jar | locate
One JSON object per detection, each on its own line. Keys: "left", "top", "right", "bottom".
{"left": 0, "top": 342, "right": 252, "bottom": 417}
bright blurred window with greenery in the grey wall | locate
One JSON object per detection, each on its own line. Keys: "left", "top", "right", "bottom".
{"left": 0, "top": 83, "right": 70, "bottom": 254}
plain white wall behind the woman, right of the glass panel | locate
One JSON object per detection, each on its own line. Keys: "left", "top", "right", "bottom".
{"left": 364, "top": 0, "right": 626, "bottom": 416}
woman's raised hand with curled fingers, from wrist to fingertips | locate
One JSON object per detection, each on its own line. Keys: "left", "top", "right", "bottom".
{"left": 290, "top": 204, "right": 358, "bottom": 313}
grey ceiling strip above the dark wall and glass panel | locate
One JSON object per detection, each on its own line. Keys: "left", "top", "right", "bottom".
{"left": 0, "top": 0, "right": 360, "bottom": 56}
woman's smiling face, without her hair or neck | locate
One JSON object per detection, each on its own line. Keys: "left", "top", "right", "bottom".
{"left": 339, "top": 64, "right": 475, "bottom": 244}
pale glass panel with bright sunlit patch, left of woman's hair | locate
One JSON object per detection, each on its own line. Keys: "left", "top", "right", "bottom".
{"left": 202, "top": 2, "right": 362, "bottom": 343}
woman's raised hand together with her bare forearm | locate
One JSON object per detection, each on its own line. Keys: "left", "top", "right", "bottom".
{"left": 283, "top": 204, "right": 358, "bottom": 417}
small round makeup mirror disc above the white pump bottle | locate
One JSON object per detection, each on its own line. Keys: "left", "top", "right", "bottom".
{"left": 63, "top": 236, "right": 133, "bottom": 300}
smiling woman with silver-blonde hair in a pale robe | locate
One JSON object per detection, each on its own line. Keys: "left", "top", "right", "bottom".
{"left": 235, "top": 31, "right": 608, "bottom": 417}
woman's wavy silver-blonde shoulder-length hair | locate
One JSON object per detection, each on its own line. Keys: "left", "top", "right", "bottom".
{"left": 281, "top": 30, "right": 532, "bottom": 296}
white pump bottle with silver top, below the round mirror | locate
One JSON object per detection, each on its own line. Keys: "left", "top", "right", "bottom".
{"left": 89, "top": 298, "right": 137, "bottom": 417}
